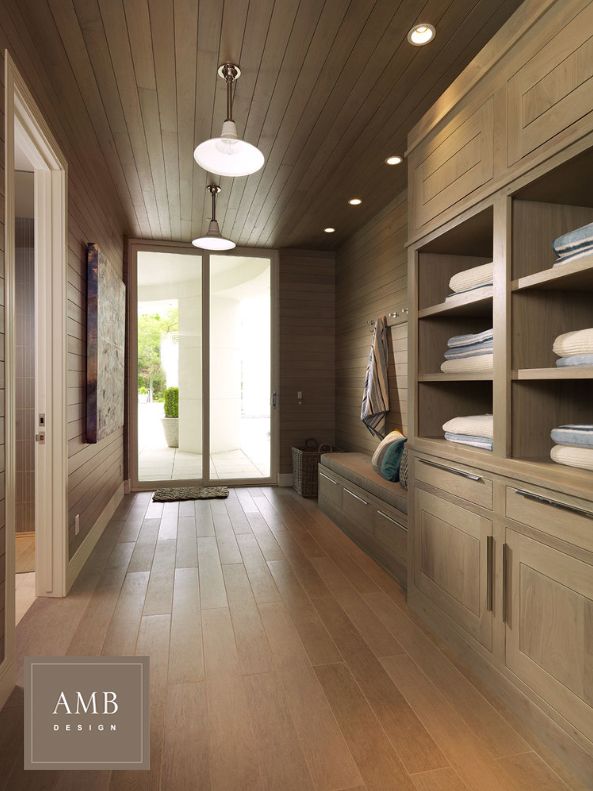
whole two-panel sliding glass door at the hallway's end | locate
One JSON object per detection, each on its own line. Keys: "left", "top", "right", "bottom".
{"left": 128, "top": 241, "right": 276, "bottom": 488}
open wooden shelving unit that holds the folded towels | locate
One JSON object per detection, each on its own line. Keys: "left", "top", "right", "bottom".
{"left": 410, "top": 150, "right": 593, "bottom": 486}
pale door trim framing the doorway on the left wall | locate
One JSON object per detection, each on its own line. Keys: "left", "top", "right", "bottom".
{"left": 4, "top": 50, "right": 68, "bottom": 688}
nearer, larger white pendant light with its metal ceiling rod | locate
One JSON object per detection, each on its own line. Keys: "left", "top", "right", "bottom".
{"left": 194, "top": 63, "right": 265, "bottom": 177}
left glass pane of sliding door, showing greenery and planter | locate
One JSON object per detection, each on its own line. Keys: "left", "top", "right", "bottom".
{"left": 137, "top": 251, "right": 203, "bottom": 481}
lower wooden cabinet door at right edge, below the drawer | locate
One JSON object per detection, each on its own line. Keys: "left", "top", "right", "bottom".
{"left": 505, "top": 530, "right": 593, "bottom": 740}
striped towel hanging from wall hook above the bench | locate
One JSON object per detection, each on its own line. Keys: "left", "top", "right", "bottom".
{"left": 360, "top": 317, "right": 389, "bottom": 439}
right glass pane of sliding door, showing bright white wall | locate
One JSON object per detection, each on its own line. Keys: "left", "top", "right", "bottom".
{"left": 209, "top": 255, "right": 272, "bottom": 480}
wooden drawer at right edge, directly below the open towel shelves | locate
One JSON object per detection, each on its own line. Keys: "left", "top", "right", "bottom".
{"left": 506, "top": 486, "right": 593, "bottom": 552}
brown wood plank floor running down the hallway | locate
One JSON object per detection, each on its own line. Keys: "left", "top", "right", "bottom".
{"left": 0, "top": 489, "right": 567, "bottom": 791}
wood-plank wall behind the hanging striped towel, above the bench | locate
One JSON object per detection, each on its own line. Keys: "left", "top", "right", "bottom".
{"left": 336, "top": 194, "right": 408, "bottom": 453}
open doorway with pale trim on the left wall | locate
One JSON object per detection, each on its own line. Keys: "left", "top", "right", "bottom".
{"left": 0, "top": 51, "right": 68, "bottom": 685}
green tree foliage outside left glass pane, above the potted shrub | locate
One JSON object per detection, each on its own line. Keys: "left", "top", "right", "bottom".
{"left": 138, "top": 308, "right": 179, "bottom": 401}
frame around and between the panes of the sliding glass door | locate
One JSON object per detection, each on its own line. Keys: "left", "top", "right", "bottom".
{"left": 126, "top": 239, "right": 280, "bottom": 491}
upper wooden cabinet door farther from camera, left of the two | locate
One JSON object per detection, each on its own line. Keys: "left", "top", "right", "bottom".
{"left": 410, "top": 97, "right": 494, "bottom": 230}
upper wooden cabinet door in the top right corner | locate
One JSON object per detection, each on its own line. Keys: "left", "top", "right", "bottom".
{"left": 507, "top": 4, "right": 593, "bottom": 165}
